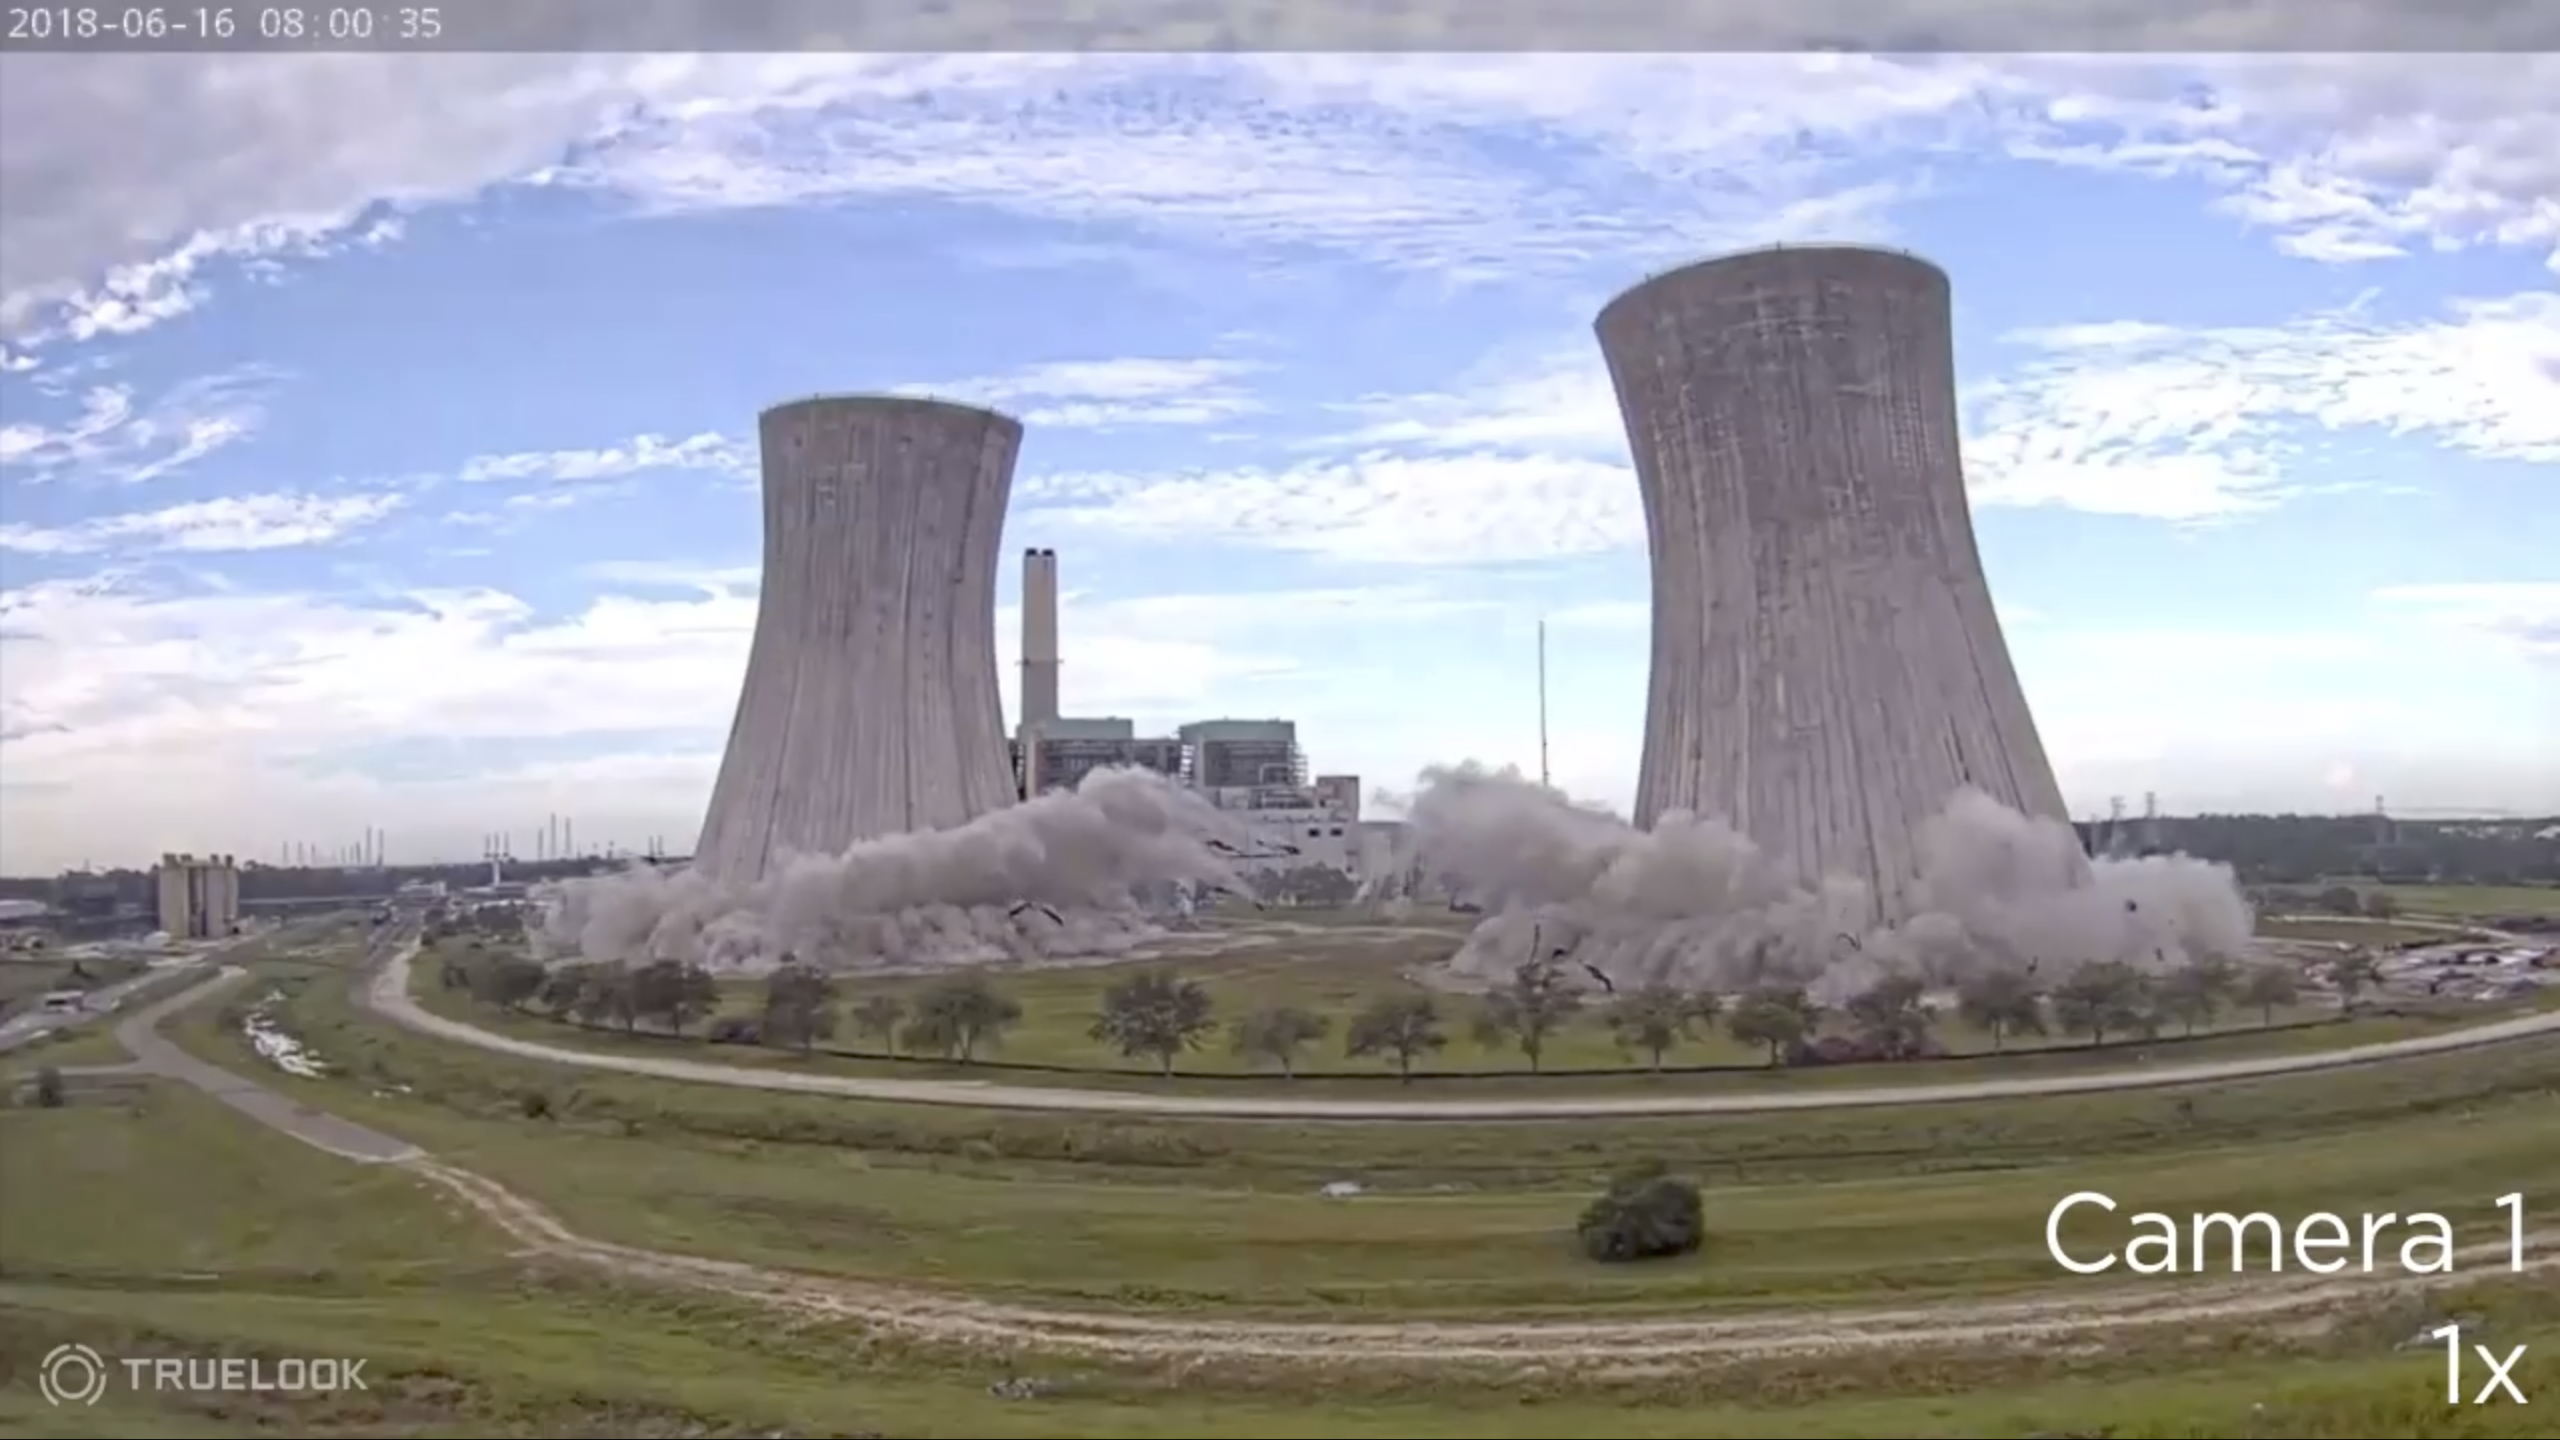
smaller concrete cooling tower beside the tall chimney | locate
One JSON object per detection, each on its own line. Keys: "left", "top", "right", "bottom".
{"left": 694, "top": 397, "right": 1021, "bottom": 884}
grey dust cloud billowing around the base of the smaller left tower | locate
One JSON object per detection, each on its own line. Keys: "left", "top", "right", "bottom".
{"left": 540, "top": 769, "right": 1242, "bottom": 971}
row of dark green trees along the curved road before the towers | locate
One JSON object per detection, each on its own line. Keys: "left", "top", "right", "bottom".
{"left": 443, "top": 951, "right": 2376, "bottom": 1079}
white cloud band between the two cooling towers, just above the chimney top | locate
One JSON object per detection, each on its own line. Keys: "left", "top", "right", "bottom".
{"left": 1021, "top": 451, "right": 1644, "bottom": 564}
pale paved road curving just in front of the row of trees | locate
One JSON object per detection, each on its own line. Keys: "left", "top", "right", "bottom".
{"left": 356, "top": 948, "right": 2560, "bottom": 1120}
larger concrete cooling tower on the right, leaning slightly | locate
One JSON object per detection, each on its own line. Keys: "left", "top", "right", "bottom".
{"left": 1597, "top": 246, "right": 2068, "bottom": 920}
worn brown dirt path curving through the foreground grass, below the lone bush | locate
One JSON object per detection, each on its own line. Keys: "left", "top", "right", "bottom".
{"left": 404, "top": 1158, "right": 2560, "bottom": 1368}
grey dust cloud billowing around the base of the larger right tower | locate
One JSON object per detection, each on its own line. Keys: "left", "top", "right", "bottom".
{"left": 1372, "top": 766, "right": 2250, "bottom": 1002}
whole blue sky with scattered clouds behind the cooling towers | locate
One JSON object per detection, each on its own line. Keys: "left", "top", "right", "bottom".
{"left": 0, "top": 56, "right": 2560, "bottom": 871}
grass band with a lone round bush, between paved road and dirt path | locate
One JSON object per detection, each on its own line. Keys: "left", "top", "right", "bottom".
{"left": 154, "top": 948, "right": 2560, "bottom": 1314}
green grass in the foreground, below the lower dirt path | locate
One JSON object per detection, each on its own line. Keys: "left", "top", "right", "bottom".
{"left": 0, "top": 1055, "right": 2560, "bottom": 1440}
